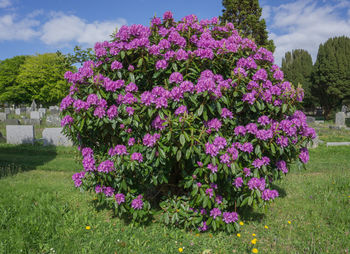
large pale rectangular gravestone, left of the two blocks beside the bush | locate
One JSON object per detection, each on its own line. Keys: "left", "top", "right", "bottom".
{"left": 6, "top": 125, "right": 34, "bottom": 145}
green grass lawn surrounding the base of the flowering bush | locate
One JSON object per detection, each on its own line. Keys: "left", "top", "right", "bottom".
{"left": 0, "top": 145, "right": 350, "bottom": 253}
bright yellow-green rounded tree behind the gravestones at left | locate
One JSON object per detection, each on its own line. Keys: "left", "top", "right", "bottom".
{"left": 17, "top": 53, "right": 73, "bottom": 105}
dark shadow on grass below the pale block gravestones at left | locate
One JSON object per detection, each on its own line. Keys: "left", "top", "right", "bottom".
{"left": 0, "top": 144, "right": 57, "bottom": 179}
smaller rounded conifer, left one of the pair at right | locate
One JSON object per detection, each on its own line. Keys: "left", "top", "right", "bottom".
{"left": 282, "top": 49, "right": 317, "bottom": 108}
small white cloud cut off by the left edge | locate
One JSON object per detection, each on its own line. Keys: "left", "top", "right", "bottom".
{"left": 0, "top": 14, "right": 40, "bottom": 41}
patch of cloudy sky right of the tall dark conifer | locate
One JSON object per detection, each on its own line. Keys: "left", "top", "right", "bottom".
{"left": 270, "top": 0, "right": 350, "bottom": 64}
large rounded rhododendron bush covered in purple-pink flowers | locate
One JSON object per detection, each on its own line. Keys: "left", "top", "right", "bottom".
{"left": 61, "top": 12, "right": 315, "bottom": 232}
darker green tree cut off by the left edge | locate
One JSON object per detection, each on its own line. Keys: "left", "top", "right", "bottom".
{"left": 0, "top": 56, "right": 29, "bottom": 104}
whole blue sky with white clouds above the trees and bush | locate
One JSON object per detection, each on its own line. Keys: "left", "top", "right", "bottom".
{"left": 0, "top": 0, "right": 350, "bottom": 64}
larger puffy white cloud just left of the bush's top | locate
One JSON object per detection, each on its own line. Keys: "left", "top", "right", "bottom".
{"left": 40, "top": 13, "right": 126, "bottom": 46}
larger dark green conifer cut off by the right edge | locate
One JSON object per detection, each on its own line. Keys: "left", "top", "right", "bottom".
{"left": 312, "top": 36, "right": 350, "bottom": 119}
